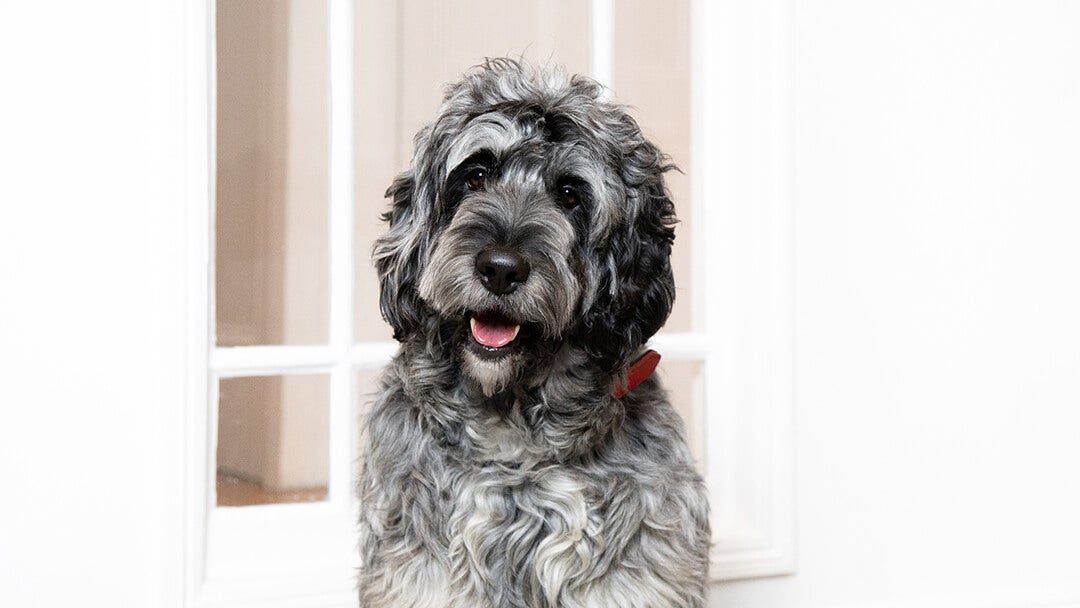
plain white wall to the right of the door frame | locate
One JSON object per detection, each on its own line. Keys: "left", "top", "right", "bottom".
{"left": 712, "top": 0, "right": 1080, "bottom": 608}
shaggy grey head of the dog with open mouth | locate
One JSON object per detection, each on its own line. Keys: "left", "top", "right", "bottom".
{"left": 374, "top": 59, "right": 675, "bottom": 394}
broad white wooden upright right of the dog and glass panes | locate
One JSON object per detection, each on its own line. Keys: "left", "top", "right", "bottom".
{"left": 691, "top": 0, "right": 795, "bottom": 580}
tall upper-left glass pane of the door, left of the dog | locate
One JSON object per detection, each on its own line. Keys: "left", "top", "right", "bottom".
{"left": 215, "top": 0, "right": 328, "bottom": 346}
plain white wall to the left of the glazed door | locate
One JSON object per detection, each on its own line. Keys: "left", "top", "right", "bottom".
{"left": 0, "top": 0, "right": 187, "bottom": 607}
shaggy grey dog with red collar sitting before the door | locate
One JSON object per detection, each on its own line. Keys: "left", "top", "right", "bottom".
{"left": 360, "top": 59, "right": 710, "bottom": 608}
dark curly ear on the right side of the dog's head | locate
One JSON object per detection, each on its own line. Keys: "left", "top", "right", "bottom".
{"left": 580, "top": 134, "right": 676, "bottom": 375}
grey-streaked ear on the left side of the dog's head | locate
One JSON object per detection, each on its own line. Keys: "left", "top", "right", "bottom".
{"left": 373, "top": 171, "right": 428, "bottom": 341}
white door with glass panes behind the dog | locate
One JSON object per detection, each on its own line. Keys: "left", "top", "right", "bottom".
{"left": 198, "top": 0, "right": 794, "bottom": 605}
